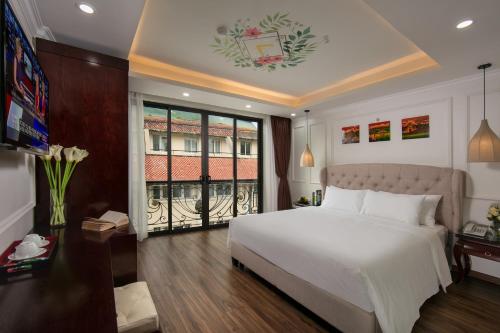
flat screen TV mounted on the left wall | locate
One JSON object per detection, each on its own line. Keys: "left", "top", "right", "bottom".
{"left": 0, "top": 0, "right": 49, "bottom": 154}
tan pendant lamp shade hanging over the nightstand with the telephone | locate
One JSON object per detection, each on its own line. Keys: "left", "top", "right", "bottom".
{"left": 468, "top": 119, "right": 500, "bottom": 162}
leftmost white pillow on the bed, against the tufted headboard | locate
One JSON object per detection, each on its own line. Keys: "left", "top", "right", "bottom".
{"left": 321, "top": 186, "right": 366, "bottom": 214}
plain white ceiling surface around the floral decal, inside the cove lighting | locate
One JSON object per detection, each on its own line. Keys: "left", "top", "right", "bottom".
{"left": 133, "top": 0, "right": 418, "bottom": 96}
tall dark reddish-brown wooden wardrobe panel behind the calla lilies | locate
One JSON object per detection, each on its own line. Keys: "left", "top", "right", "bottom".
{"left": 35, "top": 39, "right": 128, "bottom": 223}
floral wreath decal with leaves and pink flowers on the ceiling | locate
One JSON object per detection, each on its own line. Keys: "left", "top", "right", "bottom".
{"left": 210, "top": 12, "right": 328, "bottom": 72}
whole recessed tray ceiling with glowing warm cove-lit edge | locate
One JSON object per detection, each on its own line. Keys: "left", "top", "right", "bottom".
{"left": 129, "top": 0, "right": 437, "bottom": 107}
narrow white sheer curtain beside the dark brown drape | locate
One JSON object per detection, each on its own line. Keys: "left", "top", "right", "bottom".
{"left": 263, "top": 116, "right": 278, "bottom": 212}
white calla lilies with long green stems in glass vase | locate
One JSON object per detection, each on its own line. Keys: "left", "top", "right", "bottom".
{"left": 40, "top": 145, "right": 89, "bottom": 226}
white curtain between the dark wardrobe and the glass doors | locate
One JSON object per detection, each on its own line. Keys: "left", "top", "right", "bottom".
{"left": 128, "top": 93, "right": 148, "bottom": 241}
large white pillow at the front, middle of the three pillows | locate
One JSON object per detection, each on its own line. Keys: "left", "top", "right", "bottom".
{"left": 361, "top": 190, "right": 425, "bottom": 225}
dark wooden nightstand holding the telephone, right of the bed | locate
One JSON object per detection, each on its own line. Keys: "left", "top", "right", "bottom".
{"left": 453, "top": 233, "right": 500, "bottom": 283}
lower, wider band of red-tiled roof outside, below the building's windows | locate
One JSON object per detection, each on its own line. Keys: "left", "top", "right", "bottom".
{"left": 145, "top": 155, "right": 257, "bottom": 182}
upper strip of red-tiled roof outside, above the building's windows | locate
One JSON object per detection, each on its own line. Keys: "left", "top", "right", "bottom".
{"left": 144, "top": 116, "right": 257, "bottom": 139}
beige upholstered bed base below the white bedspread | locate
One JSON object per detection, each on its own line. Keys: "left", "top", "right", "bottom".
{"left": 230, "top": 241, "right": 382, "bottom": 333}
